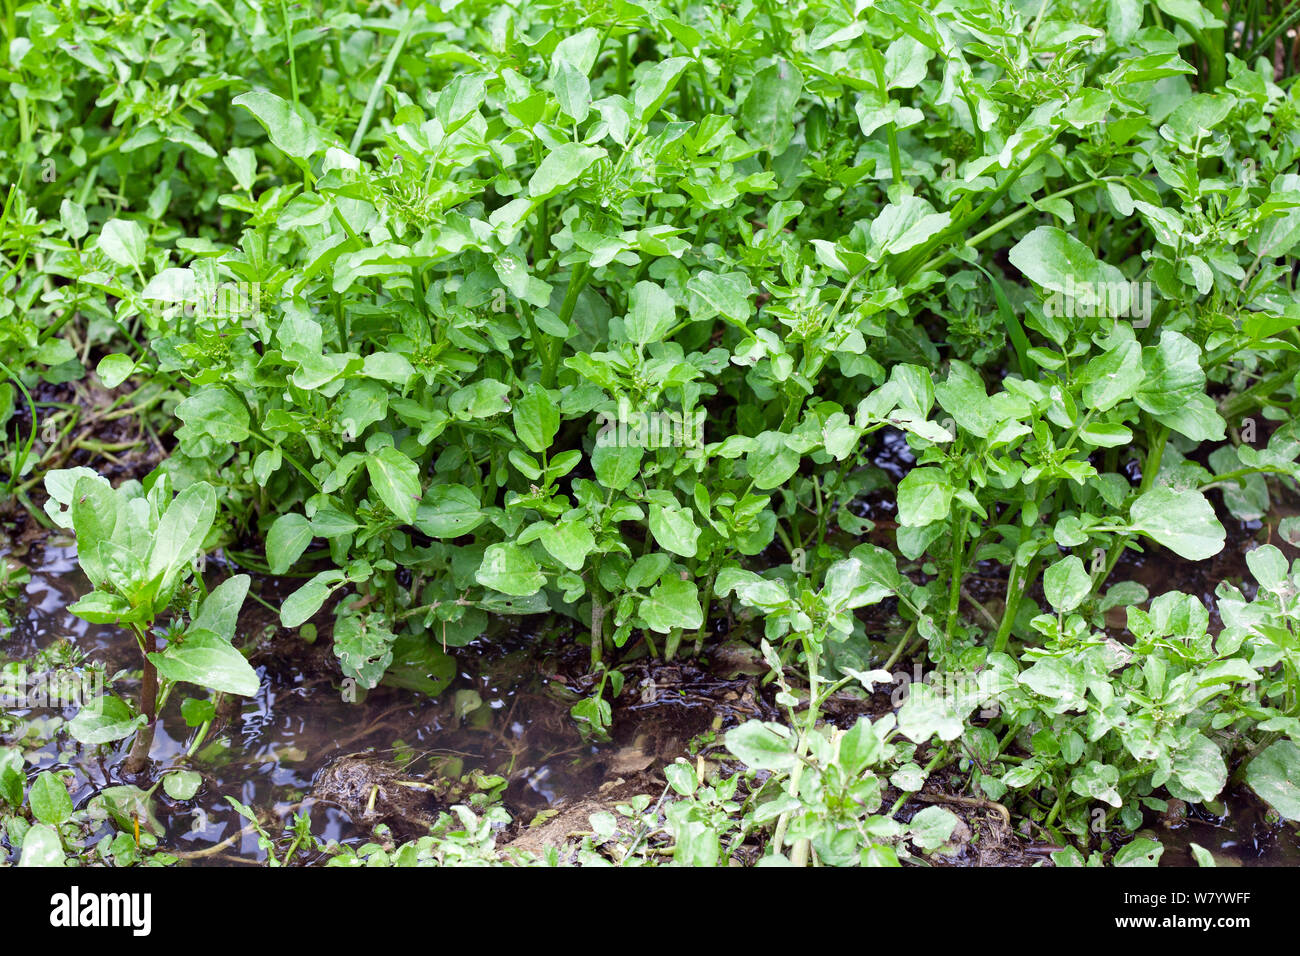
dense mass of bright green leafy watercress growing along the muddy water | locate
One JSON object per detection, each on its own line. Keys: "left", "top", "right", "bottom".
{"left": 0, "top": 0, "right": 1300, "bottom": 864}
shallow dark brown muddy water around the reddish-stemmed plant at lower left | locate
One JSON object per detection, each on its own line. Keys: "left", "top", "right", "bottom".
{"left": 0, "top": 546, "right": 738, "bottom": 865}
